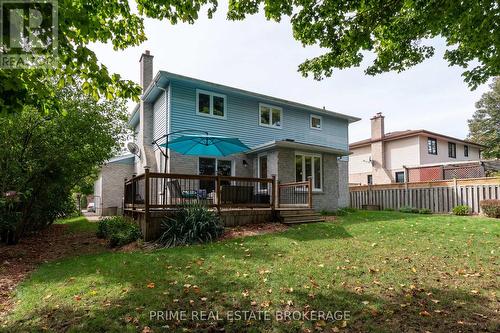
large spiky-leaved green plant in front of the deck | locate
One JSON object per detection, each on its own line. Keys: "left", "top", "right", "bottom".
{"left": 157, "top": 204, "right": 224, "bottom": 247}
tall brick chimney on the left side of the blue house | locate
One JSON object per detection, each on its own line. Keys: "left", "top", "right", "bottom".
{"left": 136, "top": 50, "right": 158, "bottom": 173}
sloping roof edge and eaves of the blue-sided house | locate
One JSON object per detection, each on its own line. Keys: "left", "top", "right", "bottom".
{"left": 133, "top": 71, "right": 361, "bottom": 123}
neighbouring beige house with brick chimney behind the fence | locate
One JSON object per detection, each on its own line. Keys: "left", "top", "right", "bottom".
{"left": 349, "top": 113, "right": 484, "bottom": 184}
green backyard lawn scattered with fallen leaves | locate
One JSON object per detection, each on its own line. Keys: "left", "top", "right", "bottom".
{"left": 4, "top": 212, "right": 500, "bottom": 332}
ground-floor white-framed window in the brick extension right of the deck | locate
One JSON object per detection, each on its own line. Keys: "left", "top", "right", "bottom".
{"left": 295, "top": 152, "right": 323, "bottom": 191}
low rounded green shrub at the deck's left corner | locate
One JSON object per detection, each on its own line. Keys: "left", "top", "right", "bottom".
{"left": 96, "top": 216, "right": 141, "bottom": 247}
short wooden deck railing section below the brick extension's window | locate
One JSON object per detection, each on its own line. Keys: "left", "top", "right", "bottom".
{"left": 278, "top": 177, "right": 312, "bottom": 208}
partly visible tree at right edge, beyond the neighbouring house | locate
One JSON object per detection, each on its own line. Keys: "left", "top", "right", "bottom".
{"left": 469, "top": 77, "right": 500, "bottom": 158}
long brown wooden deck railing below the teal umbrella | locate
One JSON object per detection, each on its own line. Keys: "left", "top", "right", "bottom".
{"left": 124, "top": 169, "right": 276, "bottom": 212}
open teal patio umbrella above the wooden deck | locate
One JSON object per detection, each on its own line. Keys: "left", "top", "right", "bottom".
{"left": 160, "top": 134, "right": 250, "bottom": 156}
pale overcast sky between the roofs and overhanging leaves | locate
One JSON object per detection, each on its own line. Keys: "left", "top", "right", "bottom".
{"left": 92, "top": 5, "right": 488, "bottom": 142}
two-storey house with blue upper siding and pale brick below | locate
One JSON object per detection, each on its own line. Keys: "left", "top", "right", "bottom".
{"left": 94, "top": 51, "right": 359, "bottom": 214}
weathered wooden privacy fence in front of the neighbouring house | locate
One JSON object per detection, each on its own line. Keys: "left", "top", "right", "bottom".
{"left": 349, "top": 177, "right": 500, "bottom": 213}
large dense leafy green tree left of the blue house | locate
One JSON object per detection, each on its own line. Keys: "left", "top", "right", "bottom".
{"left": 0, "top": 86, "right": 127, "bottom": 242}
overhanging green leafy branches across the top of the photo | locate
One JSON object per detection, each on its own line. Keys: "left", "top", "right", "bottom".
{"left": 0, "top": 0, "right": 500, "bottom": 112}
